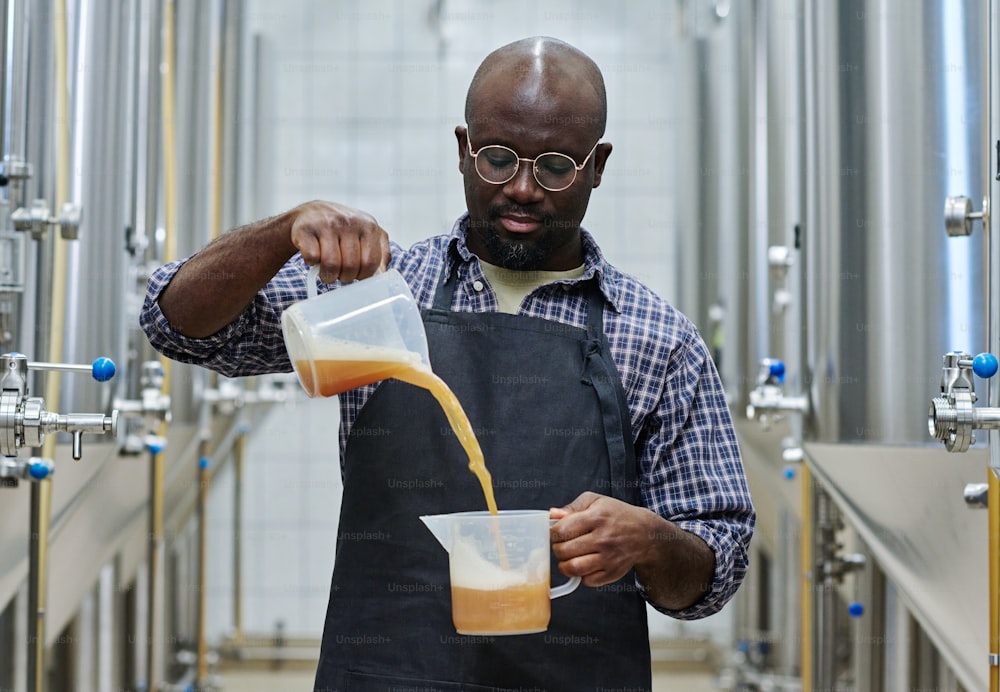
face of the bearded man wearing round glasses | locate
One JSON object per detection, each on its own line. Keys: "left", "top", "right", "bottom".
{"left": 455, "top": 89, "right": 611, "bottom": 271}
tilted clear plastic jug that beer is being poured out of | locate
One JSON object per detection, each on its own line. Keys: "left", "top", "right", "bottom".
{"left": 281, "top": 267, "right": 430, "bottom": 397}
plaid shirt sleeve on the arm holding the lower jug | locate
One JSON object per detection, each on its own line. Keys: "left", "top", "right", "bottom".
{"left": 639, "top": 331, "right": 755, "bottom": 620}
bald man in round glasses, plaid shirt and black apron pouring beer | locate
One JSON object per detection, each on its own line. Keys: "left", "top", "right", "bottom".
{"left": 142, "top": 38, "right": 754, "bottom": 692}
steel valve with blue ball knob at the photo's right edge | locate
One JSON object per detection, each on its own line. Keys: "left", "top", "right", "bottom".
{"left": 927, "top": 351, "right": 1000, "bottom": 452}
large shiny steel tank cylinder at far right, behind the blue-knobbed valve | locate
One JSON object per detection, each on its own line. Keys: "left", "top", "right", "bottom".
{"left": 802, "top": 0, "right": 988, "bottom": 443}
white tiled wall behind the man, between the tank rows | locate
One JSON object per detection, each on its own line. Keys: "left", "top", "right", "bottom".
{"left": 205, "top": 0, "right": 736, "bottom": 648}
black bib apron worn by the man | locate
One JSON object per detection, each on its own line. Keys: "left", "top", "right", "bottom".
{"left": 315, "top": 272, "right": 652, "bottom": 692}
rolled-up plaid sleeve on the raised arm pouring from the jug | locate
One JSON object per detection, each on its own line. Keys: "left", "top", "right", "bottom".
{"left": 139, "top": 256, "right": 305, "bottom": 377}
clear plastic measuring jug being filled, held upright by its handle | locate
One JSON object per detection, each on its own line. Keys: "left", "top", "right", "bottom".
{"left": 420, "top": 510, "right": 580, "bottom": 635}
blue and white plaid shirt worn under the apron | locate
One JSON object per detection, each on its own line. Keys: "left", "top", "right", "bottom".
{"left": 140, "top": 215, "right": 755, "bottom": 619}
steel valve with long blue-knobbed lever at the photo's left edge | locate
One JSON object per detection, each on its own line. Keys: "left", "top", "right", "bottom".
{"left": 0, "top": 353, "right": 118, "bottom": 460}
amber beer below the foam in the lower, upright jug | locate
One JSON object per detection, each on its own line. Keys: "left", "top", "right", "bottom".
{"left": 451, "top": 580, "right": 552, "bottom": 635}
